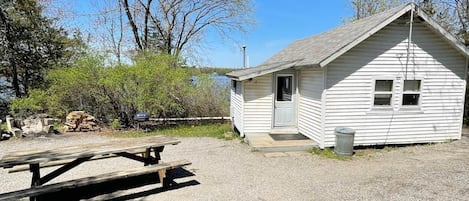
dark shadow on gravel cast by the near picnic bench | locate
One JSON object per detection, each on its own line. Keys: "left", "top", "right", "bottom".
{"left": 37, "top": 168, "right": 200, "bottom": 201}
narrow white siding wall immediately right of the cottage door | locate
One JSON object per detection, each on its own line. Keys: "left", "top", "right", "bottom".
{"left": 298, "top": 69, "right": 324, "bottom": 144}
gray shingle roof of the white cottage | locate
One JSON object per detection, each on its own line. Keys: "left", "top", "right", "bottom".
{"left": 227, "top": 3, "right": 468, "bottom": 80}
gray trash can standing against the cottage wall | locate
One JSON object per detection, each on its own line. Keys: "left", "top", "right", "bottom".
{"left": 334, "top": 127, "right": 355, "bottom": 156}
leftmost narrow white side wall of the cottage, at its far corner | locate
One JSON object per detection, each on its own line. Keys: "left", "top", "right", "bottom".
{"left": 230, "top": 81, "right": 244, "bottom": 135}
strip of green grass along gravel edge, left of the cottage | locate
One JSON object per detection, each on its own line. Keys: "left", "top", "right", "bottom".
{"left": 116, "top": 123, "right": 237, "bottom": 140}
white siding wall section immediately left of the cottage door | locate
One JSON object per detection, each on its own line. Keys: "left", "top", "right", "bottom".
{"left": 243, "top": 74, "right": 274, "bottom": 134}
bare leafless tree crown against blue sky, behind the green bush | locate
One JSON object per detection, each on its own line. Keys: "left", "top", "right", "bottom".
{"left": 119, "top": 0, "right": 253, "bottom": 57}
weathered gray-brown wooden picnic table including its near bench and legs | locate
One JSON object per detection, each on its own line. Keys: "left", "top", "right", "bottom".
{"left": 0, "top": 136, "right": 191, "bottom": 201}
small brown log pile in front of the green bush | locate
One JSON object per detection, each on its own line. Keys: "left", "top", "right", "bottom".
{"left": 65, "top": 111, "right": 100, "bottom": 132}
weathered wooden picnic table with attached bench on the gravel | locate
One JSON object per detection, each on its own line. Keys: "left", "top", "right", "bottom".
{"left": 0, "top": 136, "right": 190, "bottom": 200}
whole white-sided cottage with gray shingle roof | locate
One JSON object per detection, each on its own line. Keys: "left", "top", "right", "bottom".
{"left": 227, "top": 3, "right": 469, "bottom": 148}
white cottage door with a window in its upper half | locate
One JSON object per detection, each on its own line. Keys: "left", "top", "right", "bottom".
{"left": 274, "top": 74, "right": 296, "bottom": 127}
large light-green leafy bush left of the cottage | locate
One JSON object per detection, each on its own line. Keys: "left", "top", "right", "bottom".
{"left": 10, "top": 54, "right": 229, "bottom": 126}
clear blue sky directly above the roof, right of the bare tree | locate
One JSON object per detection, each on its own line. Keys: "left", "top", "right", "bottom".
{"left": 209, "top": 0, "right": 352, "bottom": 68}
